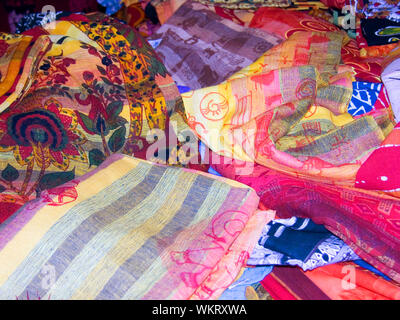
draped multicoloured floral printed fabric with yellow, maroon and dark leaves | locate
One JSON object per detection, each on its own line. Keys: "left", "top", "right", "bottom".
{"left": 0, "top": 14, "right": 193, "bottom": 220}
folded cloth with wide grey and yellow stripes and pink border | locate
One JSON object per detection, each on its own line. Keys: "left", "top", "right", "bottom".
{"left": 0, "top": 154, "right": 274, "bottom": 300}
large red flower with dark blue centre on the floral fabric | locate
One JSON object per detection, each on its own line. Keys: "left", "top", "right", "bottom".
{"left": 0, "top": 98, "right": 88, "bottom": 196}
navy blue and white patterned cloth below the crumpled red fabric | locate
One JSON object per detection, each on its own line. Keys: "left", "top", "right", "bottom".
{"left": 247, "top": 217, "right": 360, "bottom": 271}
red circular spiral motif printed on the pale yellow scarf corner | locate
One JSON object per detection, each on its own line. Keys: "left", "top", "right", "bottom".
{"left": 200, "top": 92, "right": 229, "bottom": 121}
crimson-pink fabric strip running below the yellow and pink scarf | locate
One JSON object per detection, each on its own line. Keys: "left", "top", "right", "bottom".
{"left": 210, "top": 152, "right": 400, "bottom": 282}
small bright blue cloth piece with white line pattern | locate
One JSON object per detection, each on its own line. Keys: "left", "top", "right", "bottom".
{"left": 347, "top": 81, "right": 382, "bottom": 116}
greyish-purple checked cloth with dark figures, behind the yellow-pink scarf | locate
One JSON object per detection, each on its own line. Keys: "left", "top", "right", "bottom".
{"left": 150, "top": 1, "right": 280, "bottom": 89}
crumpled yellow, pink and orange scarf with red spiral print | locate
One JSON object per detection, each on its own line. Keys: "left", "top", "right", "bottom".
{"left": 182, "top": 32, "right": 393, "bottom": 185}
